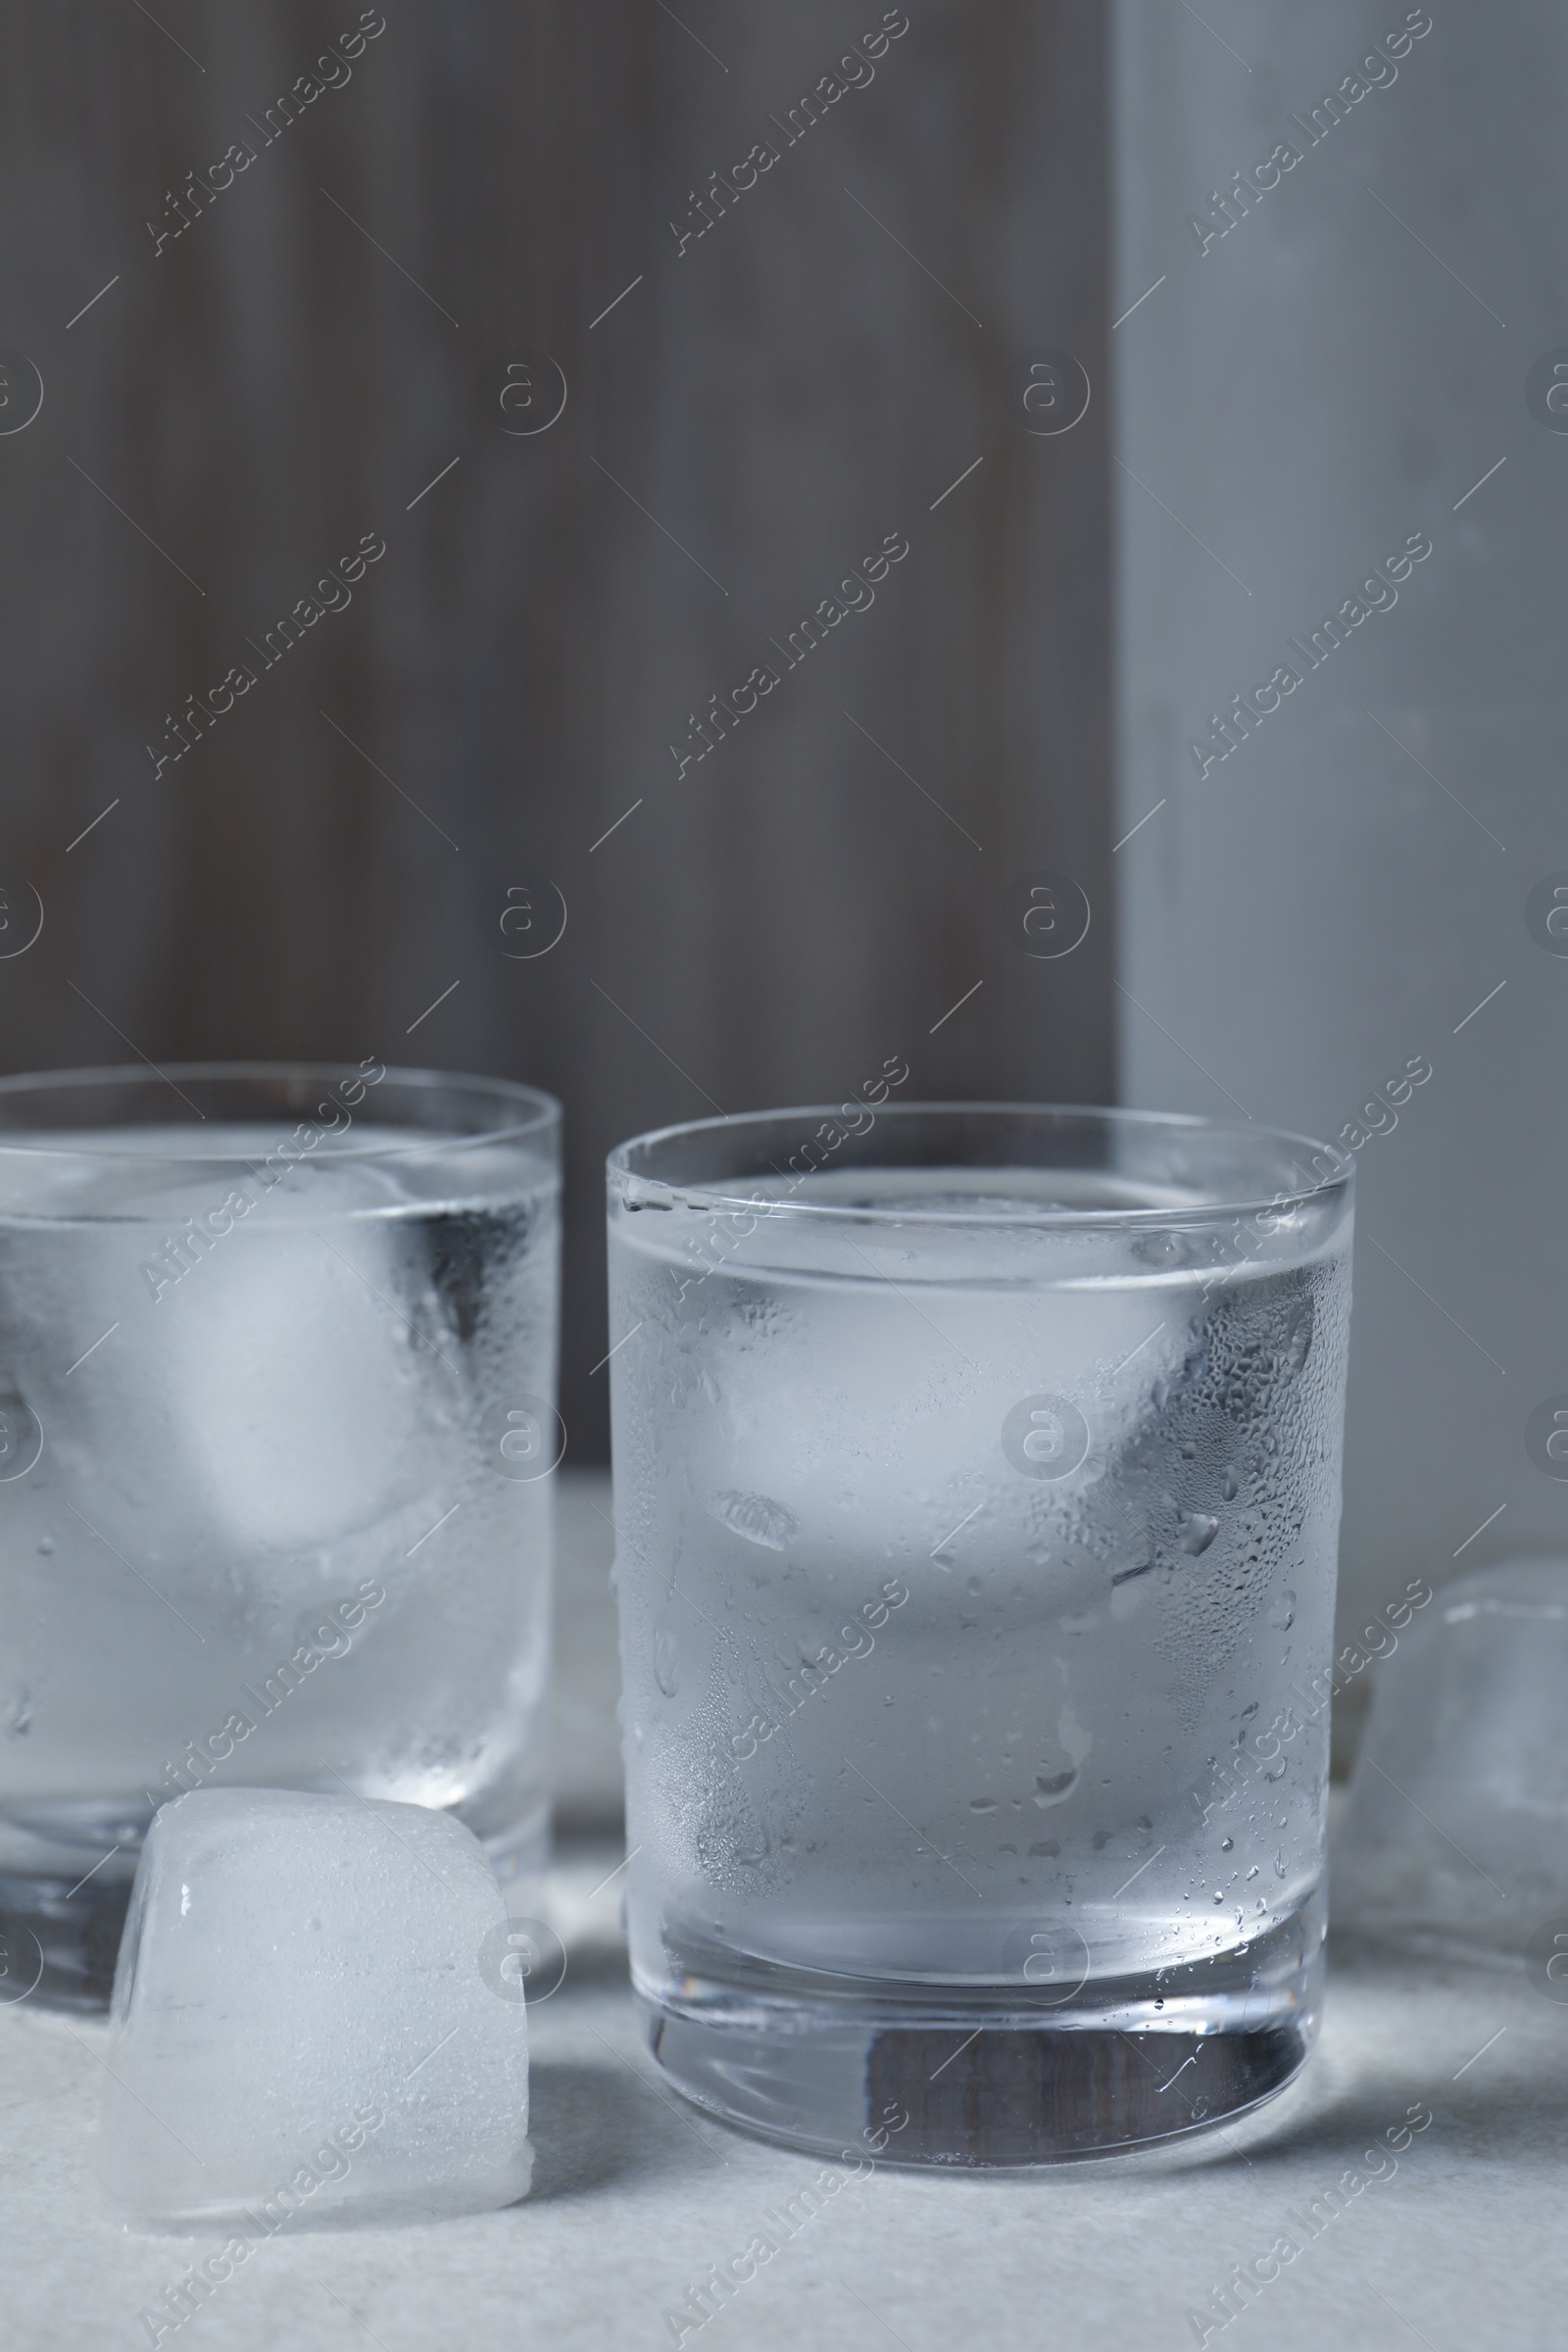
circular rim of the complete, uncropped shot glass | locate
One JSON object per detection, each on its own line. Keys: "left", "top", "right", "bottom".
{"left": 607, "top": 1101, "right": 1356, "bottom": 1233}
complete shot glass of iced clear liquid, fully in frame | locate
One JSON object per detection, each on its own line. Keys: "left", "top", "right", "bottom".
{"left": 609, "top": 1089, "right": 1351, "bottom": 2166}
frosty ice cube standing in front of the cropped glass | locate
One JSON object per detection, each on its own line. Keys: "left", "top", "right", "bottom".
{"left": 99, "top": 1788, "right": 531, "bottom": 2236}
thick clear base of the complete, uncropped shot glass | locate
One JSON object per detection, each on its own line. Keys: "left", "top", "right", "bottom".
{"left": 637, "top": 1900, "right": 1324, "bottom": 2171}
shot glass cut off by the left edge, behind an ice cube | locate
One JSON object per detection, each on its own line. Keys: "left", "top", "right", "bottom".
{"left": 0, "top": 1063, "right": 562, "bottom": 2006}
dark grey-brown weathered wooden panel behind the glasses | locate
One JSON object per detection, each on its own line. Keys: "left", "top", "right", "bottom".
{"left": 0, "top": 0, "right": 1112, "bottom": 1456}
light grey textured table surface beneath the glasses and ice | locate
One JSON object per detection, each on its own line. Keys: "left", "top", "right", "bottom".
{"left": 0, "top": 1484, "right": 1568, "bottom": 2352}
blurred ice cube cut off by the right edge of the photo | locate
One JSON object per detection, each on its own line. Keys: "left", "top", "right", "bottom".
{"left": 1331, "top": 1559, "right": 1568, "bottom": 1954}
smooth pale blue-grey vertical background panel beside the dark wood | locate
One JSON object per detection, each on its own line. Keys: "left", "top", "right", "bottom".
{"left": 1112, "top": 0, "right": 1568, "bottom": 1719}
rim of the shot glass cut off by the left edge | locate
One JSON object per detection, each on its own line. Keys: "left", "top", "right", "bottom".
{"left": 0, "top": 1058, "right": 562, "bottom": 1166}
